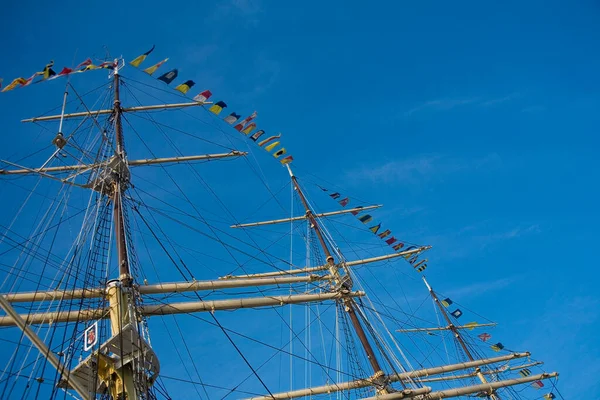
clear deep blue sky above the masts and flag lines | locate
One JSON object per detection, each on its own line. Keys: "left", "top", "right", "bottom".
{"left": 0, "top": 0, "right": 600, "bottom": 398}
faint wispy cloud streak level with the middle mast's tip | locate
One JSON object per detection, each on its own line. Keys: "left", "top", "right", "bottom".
{"left": 346, "top": 153, "right": 502, "bottom": 184}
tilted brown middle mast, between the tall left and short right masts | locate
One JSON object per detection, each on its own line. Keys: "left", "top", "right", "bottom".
{"left": 286, "top": 164, "right": 388, "bottom": 395}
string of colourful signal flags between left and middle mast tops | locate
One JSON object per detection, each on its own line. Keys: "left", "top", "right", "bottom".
{"left": 129, "top": 46, "right": 294, "bottom": 165}
